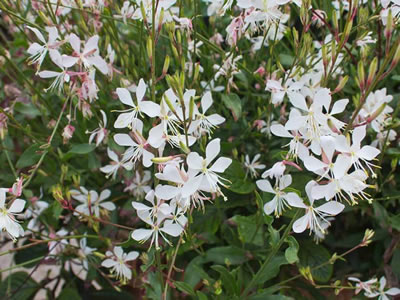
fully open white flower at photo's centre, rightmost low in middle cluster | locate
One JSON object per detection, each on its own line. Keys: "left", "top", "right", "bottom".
{"left": 182, "top": 139, "right": 232, "bottom": 200}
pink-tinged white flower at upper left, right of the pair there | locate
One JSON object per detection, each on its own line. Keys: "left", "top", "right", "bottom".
{"left": 68, "top": 33, "right": 108, "bottom": 75}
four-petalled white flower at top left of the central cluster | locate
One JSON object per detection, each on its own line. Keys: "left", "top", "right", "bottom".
{"left": 114, "top": 79, "right": 160, "bottom": 129}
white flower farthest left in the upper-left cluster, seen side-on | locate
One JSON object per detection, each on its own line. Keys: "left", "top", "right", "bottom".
{"left": 26, "top": 26, "right": 59, "bottom": 69}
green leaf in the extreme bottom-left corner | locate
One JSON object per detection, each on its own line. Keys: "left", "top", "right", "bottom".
{"left": 0, "top": 272, "right": 38, "bottom": 300}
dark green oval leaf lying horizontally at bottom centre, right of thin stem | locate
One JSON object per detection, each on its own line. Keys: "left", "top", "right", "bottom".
{"left": 205, "top": 246, "right": 249, "bottom": 265}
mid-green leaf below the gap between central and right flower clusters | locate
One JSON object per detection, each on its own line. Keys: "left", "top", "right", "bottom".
{"left": 232, "top": 215, "right": 264, "bottom": 246}
